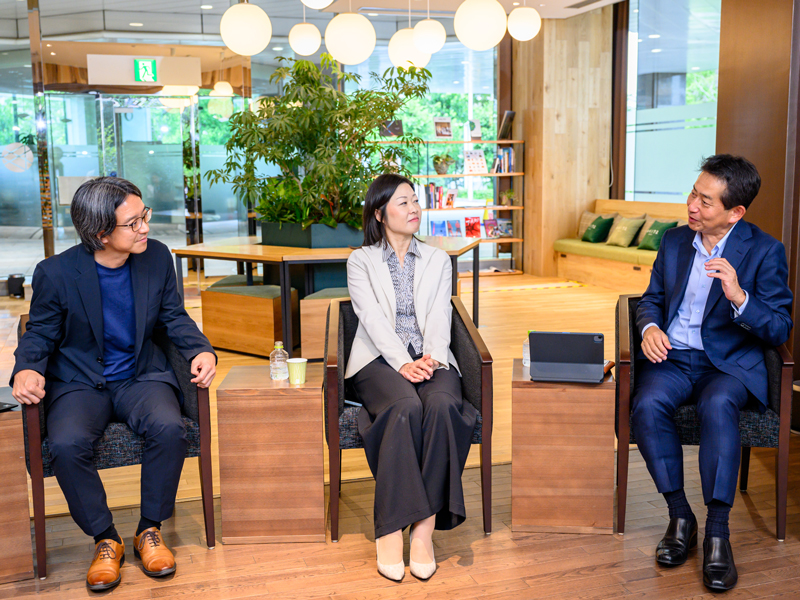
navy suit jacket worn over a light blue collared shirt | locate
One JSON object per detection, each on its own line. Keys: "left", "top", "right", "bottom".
{"left": 636, "top": 221, "right": 792, "bottom": 405}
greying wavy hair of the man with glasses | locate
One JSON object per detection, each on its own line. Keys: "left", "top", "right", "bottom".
{"left": 70, "top": 177, "right": 142, "bottom": 253}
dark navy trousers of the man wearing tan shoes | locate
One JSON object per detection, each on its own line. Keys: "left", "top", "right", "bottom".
{"left": 46, "top": 379, "right": 187, "bottom": 536}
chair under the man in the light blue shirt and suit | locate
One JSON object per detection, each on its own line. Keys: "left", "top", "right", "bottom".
{"left": 616, "top": 294, "right": 794, "bottom": 541}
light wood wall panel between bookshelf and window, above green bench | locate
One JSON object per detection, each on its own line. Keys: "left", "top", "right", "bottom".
{"left": 512, "top": 6, "right": 613, "bottom": 276}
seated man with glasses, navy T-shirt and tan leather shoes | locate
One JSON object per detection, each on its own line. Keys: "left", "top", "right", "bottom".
{"left": 11, "top": 177, "right": 216, "bottom": 591}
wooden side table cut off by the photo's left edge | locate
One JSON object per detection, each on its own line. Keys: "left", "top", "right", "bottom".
{"left": 0, "top": 411, "right": 33, "bottom": 583}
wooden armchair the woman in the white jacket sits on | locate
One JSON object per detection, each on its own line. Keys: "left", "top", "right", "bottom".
{"left": 323, "top": 296, "right": 493, "bottom": 542}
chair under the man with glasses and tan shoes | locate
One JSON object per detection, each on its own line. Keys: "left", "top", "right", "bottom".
{"left": 17, "top": 315, "right": 215, "bottom": 579}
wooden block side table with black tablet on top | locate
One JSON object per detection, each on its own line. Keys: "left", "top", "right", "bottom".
{"left": 511, "top": 359, "right": 615, "bottom": 534}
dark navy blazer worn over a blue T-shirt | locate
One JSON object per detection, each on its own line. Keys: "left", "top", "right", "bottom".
{"left": 11, "top": 239, "right": 214, "bottom": 407}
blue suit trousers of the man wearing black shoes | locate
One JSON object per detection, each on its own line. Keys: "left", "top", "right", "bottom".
{"left": 631, "top": 350, "right": 751, "bottom": 505}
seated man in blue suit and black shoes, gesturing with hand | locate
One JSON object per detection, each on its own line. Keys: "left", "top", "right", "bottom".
{"left": 631, "top": 154, "right": 792, "bottom": 590}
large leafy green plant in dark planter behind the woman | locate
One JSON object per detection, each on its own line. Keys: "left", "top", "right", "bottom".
{"left": 206, "top": 54, "right": 431, "bottom": 248}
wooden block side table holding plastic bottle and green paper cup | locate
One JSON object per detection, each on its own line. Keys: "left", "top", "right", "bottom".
{"left": 217, "top": 363, "right": 325, "bottom": 544}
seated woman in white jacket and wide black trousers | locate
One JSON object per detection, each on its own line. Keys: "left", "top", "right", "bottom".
{"left": 345, "top": 174, "right": 477, "bottom": 581}
